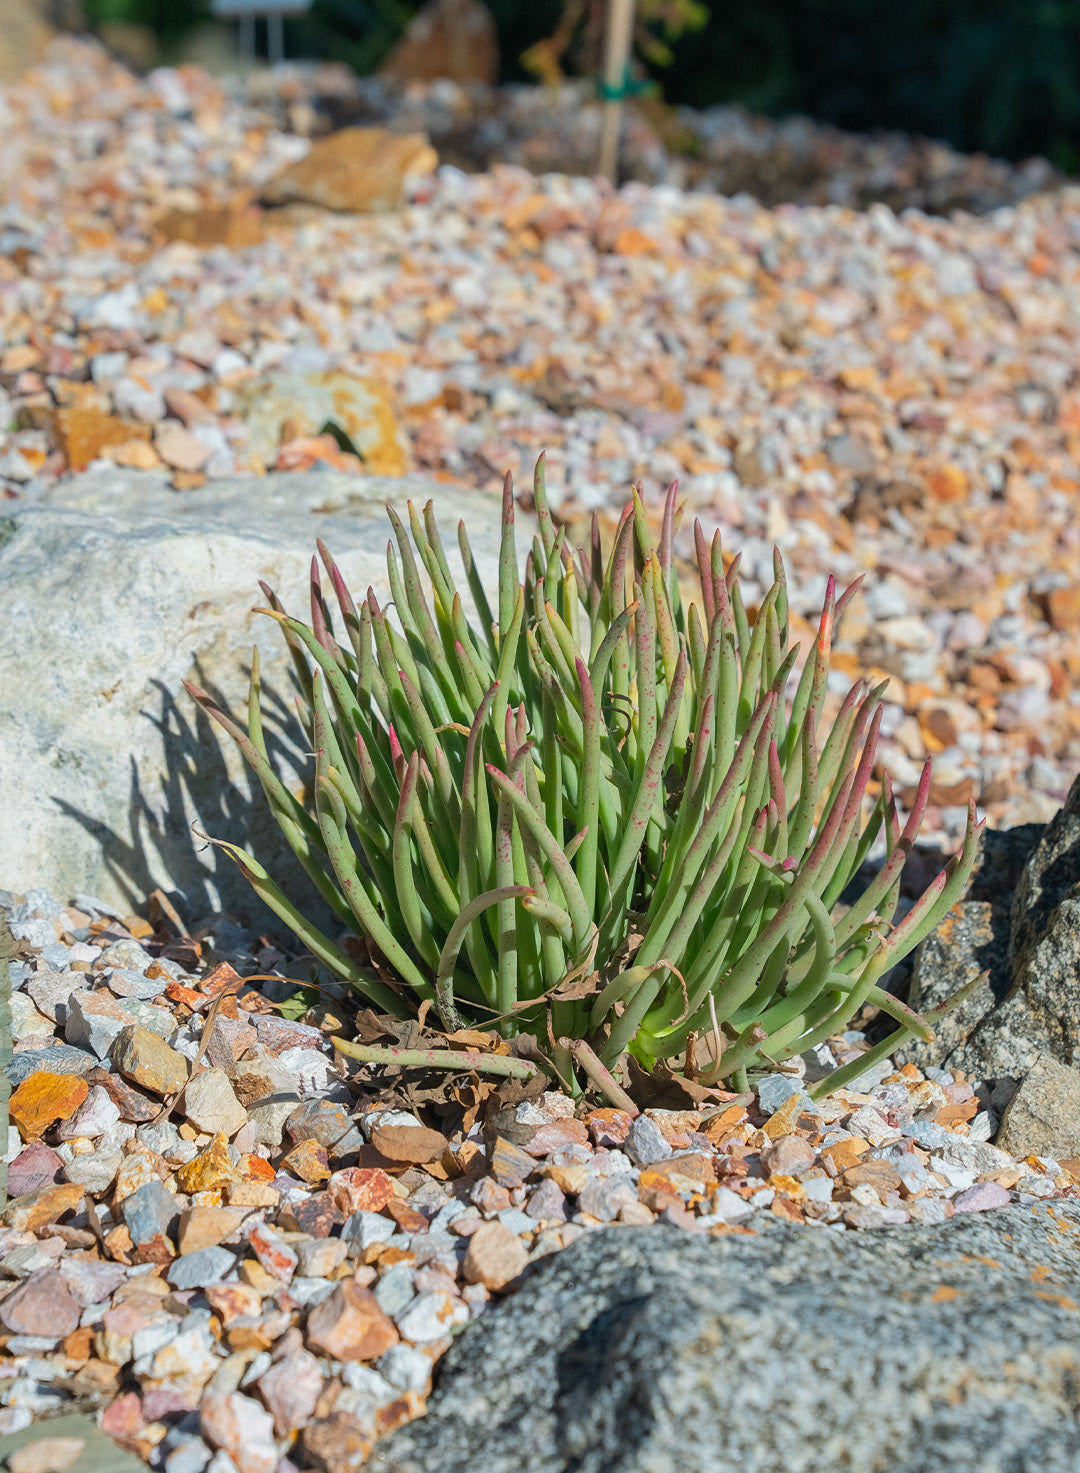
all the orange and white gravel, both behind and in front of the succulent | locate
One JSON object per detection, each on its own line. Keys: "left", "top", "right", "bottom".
{"left": 0, "top": 41, "right": 1080, "bottom": 1455}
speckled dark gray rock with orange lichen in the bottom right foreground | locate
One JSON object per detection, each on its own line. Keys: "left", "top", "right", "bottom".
{"left": 367, "top": 1202, "right": 1080, "bottom": 1473}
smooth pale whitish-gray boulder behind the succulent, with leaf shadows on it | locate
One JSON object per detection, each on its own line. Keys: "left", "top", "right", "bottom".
{"left": 0, "top": 468, "right": 506, "bottom": 922}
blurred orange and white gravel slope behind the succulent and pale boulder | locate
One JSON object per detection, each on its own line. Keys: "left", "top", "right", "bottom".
{"left": 0, "top": 41, "right": 1080, "bottom": 848}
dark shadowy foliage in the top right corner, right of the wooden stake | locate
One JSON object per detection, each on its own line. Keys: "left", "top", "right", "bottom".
{"left": 665, "top": 0, "right": 1080, "bottom": 171}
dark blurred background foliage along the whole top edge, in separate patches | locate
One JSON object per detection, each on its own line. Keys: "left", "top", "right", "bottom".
{"left": 84, "top": 0, "right": 1080, "bottom": 172}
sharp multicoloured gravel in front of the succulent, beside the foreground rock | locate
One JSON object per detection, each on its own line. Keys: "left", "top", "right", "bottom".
{"left": 0, "top": 891, "right": 1080, "bottom": 1473}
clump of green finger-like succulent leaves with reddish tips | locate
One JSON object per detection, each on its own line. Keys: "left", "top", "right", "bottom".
{"left": 189, "top": 460, "right": 978, "bottom": 1093}
